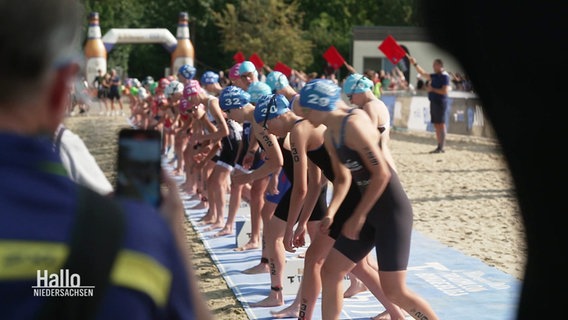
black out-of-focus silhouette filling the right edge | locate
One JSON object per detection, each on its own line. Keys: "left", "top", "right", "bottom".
{"left": 419, "top": 1, "right": 568, "bottom": 319}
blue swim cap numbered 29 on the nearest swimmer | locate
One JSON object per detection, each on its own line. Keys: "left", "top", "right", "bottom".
{"left": 300, "top": 79, "right": 341, "bottom": 111}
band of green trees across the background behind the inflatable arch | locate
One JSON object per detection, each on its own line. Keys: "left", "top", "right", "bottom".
{"left": 80, "top": 0, "right": 419, "bottom": 78}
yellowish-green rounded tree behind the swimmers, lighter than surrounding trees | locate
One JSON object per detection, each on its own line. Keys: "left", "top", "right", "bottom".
{"left": 212, "top": 0, "right": 313, "bottom": 69}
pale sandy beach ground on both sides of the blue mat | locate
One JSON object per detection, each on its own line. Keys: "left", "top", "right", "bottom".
{"left": 65, "top": 105, "right": 526, "bottom": 320}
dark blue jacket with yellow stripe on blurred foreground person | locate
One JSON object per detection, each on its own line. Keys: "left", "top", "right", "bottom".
{"left": 0, "top": 133, "right": 195, "bottom": 320}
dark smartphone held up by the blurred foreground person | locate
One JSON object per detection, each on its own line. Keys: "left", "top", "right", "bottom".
{"left": 116, "top": 129, "right": 162, "bottom": 208}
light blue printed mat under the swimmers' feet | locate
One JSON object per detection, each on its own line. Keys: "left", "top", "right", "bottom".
{"left": 186, "top": 203, "right": 521, "bottom": 320}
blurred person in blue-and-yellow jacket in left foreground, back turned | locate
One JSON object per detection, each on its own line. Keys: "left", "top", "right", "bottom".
{"left": 0, "top": 0, "right": 211, "bottom": 319}
